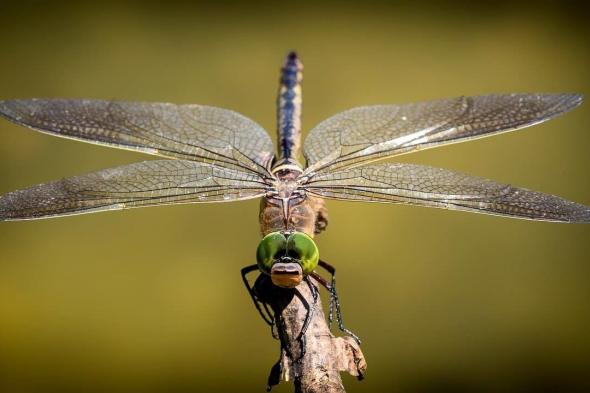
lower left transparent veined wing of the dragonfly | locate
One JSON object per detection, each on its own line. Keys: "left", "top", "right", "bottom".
{"left": 0, "top": 160, "right": 266, "bottom": 221}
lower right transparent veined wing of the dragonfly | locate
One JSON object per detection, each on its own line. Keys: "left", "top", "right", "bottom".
{"left": 302, "top": 164, "right": 590, "bottom": 223}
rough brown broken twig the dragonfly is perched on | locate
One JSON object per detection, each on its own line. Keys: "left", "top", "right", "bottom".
{"left": 258, "top": 280, "right": 367, "bottom": 393}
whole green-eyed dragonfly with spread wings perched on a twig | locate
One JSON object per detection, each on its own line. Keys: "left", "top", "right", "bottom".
{"left": 0, "top": 52, "right": 590, "bottom": 344}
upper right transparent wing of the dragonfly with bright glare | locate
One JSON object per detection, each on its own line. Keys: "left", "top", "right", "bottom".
{"left": 303, "top": 94, "right": 583, "bottom": 174}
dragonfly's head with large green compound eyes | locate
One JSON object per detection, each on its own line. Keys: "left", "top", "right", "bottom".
{"left": 256, "top": 232, "right": 320, "bottom": 288}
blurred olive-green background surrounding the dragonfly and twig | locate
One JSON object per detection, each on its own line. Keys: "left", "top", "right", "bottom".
{"left": 0, "top": 2, "right": 590, "bottom": 393}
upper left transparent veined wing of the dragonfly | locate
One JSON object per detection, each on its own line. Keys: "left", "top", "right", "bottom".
{"left": 0, "top": 99, "right": 273, "bottom": 173}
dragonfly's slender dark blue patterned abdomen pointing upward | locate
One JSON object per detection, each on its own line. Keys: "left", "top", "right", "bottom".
{"left": 277, "top": 52, "right": 303, "bottom": 160}
